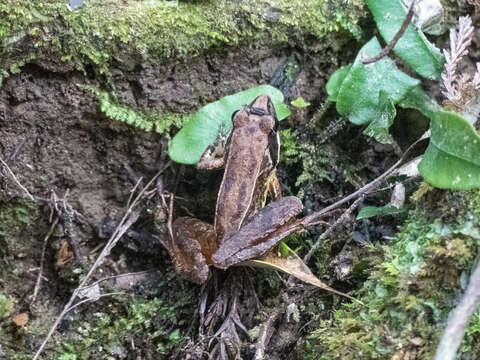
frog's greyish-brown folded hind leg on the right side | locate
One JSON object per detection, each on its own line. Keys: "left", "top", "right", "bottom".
{"left": 212, "top": 196, "right": 303, "bottom": 269}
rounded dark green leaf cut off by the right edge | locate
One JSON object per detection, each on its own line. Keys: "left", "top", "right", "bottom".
{"left": 418, "top": 111, "right": 480, "bottom": 189}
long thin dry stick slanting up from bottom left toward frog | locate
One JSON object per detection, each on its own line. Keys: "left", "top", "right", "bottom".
{"left": 33, "top": 171, "right": 161, "bottom": 360}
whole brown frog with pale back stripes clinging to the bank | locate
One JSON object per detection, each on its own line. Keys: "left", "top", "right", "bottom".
{"left": 166, "top": 95, "right": 303, "bottom": 283}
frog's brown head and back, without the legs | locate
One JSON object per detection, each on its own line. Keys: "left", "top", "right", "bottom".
{"left": 214, "top": 95, "right": 277, "bottom": 242}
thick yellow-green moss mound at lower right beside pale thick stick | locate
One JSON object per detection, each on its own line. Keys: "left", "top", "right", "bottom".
{"left": 303, "top": 191, "right": 480, "bottom": 360}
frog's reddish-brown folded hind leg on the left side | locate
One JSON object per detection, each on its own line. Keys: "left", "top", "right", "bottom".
{"left": 166, "top": 217, "right": 218, "bottom": 284}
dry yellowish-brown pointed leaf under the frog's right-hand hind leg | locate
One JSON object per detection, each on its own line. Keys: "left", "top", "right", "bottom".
{"left": 246, "top": 248, "right": 363, "bottom": 305}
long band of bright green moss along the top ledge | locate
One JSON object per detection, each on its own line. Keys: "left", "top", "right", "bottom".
{"left": 0, "top": 0, "right": 364, "bottom": 75}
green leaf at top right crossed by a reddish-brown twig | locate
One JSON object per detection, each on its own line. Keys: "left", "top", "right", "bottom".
{"left": 367, "top": 0, "right": 445, "bottom": 80}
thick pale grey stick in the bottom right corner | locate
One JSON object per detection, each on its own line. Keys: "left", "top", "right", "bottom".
{"left": 434, "top": 263, "right": 480, "bottom": 360}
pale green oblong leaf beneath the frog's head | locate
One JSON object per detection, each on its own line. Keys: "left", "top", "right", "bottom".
{"left": 168, "top": 85, "right": 290, "bottom": 165}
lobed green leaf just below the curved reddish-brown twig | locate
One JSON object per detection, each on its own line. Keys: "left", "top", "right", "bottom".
{"left": 337, "top": 37, "right": 420, "bottom": 125}
